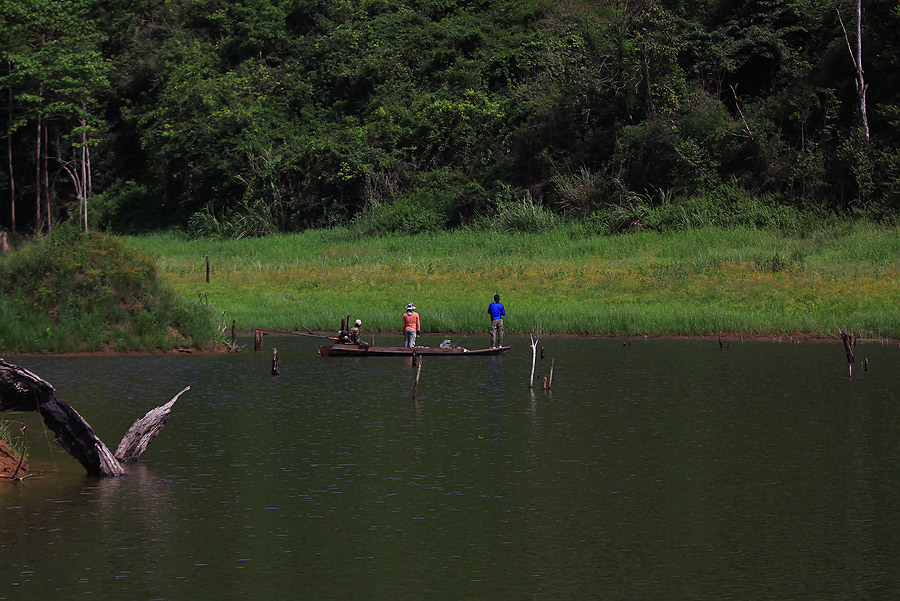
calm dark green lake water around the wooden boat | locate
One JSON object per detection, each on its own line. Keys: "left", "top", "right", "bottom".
{"left": 0, "top": 336, "right": 900, "bottom": 601}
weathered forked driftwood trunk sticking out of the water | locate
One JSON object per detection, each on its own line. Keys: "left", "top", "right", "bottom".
{"left": 0, "top": 359, "right": 187, "bottom": 476}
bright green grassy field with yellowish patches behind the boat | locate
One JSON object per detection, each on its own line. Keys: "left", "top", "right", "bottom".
{"left": 130, "top": 224, "right": 900, "bottom": 338}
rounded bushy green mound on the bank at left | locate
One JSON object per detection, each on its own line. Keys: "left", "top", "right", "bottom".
{"left": 0, "top": 227, "right": 216, "bottom": 352}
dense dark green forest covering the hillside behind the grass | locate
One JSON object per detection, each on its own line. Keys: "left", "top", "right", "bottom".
{"left": 0, "top": 0, "right": 900, "bottom": 236}
